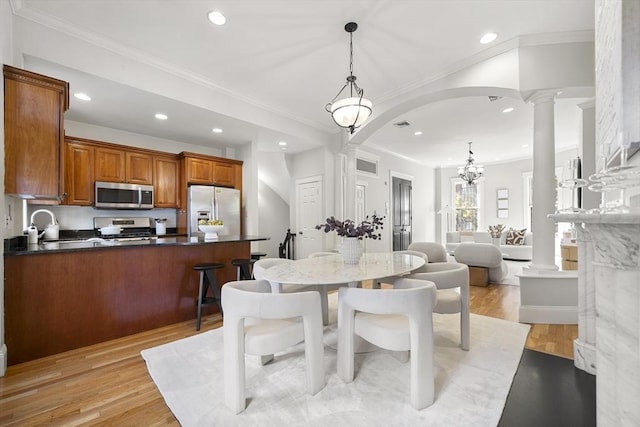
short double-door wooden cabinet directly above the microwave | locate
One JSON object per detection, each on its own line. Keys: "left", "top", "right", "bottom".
{"left": 95, "top": 147, "right": 153, "bottom": 185}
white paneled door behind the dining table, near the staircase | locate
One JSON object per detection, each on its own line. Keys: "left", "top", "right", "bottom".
{"left": 295, "top": 176, "right": 326, "bottom": 259}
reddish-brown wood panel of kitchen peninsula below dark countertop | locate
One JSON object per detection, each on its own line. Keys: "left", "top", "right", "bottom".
{"left": 4, "top": 241, "right": 250, "bottom": 365}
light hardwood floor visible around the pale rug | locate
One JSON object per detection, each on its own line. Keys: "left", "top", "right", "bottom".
{"left": 0, "top": 285, "right": 577, "bottom": 426}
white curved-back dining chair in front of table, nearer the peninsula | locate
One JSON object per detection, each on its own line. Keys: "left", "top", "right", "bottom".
{"left": 222, "top": 280, "right": 325, "bottom": 414}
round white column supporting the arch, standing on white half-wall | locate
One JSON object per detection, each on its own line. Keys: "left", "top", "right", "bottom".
{"left": 525, "top": 90, "right": 558, "bottom": 274}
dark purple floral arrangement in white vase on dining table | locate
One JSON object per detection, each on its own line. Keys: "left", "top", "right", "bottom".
{"left": 316, "top": 215, "right": 384, "bottom": 264}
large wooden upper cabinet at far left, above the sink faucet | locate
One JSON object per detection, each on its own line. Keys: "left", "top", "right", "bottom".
{"left": 3, "top": 65, "right": 69, "bottom": 199}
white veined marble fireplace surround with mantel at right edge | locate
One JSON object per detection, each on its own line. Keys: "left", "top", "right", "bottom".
{"left": 549, "top": 213, "right": 640, "bottom": 425}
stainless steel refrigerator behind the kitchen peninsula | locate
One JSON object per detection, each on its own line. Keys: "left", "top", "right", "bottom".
{"left": 187, "top": 185, "right": 241, "bottom": 236}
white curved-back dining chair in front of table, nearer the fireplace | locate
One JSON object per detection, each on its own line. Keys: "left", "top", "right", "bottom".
{"left": 338, "top": 278, "right": 436, "bottom": 410}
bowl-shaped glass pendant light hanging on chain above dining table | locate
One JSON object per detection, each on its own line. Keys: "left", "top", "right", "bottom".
{"left": 325, "top": 22, "right": 372, "bottom": 133}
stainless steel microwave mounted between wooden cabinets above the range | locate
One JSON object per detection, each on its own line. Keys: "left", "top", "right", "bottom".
{"left": 95, "top": 181, "right": 153, "bottom": 209}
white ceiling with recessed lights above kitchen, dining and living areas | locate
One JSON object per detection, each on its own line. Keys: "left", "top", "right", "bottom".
{"left": 12, "top": 0, "right": 594, "bottom": 166}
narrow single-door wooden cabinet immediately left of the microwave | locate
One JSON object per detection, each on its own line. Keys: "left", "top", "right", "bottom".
{"left": 63, "top": 139, "right": 95, "bottom": 206}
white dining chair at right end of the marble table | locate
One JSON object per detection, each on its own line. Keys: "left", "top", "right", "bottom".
{"left": 407, "top": 262, "right": 470, "bottom": 350}
